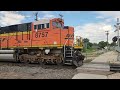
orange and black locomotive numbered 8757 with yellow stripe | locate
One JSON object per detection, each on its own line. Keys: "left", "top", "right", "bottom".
{"left": 0, "top": 18, "right": 84, "bottom": 66}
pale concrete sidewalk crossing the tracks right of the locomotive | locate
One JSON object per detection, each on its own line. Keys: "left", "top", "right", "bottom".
{"left": 72, "top": 51, "right": 120, "bottom": 79}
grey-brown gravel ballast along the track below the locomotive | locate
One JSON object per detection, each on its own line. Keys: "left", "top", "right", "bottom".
{"left": 0, "top": 62, "right": 77, "bottom": 79}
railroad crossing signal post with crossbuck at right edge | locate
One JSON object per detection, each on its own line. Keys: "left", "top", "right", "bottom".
{"left": 114, "top": 18, "right": 120, "bottom": 61}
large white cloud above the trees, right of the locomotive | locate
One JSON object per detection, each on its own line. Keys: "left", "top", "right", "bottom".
{"left": 75, "top": 22, "right": 116, "bottom": 43}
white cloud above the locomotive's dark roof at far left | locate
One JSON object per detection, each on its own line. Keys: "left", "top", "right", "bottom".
{"left": 0, "top": 11, "right": 25, "bottom": 26}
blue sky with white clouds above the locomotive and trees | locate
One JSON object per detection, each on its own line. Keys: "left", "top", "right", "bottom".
{"left": 0, "top": 11, "right": 120, "bottom": 43}
